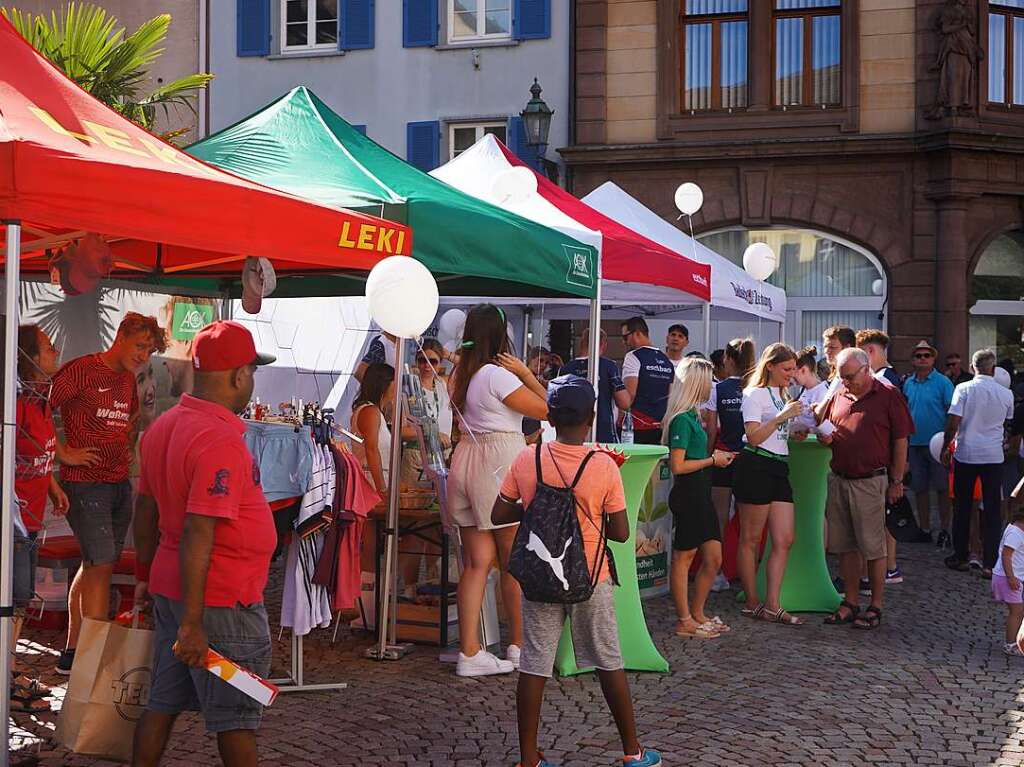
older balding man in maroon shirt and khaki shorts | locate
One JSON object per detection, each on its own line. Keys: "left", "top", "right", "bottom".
{"left": 819, "top": 349, "right": 913, "bottom": 629}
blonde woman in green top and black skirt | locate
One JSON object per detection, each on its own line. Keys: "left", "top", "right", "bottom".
{"left": 663, "top": 357, "right": 735, "bottom": 639}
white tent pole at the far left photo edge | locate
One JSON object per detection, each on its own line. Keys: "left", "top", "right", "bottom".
{"left": 0, "top": 221, "right": 22, "bottom": 767}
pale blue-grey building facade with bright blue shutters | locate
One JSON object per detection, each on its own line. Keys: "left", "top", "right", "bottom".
{"left": 209, "top": 0, "right": 571, "bottom": 170}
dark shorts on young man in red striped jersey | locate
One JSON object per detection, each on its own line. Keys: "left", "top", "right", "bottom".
{"left": 63, "top": 479, "right": 132, "bottom": 566}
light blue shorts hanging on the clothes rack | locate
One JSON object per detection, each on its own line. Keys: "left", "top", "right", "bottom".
{"left": 245, "top": 423, "right": 313, "bottom": 503}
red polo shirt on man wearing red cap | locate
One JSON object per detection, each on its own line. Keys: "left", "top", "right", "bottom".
{"left": 139, "top": 394, "right": 278, "bottom": 607}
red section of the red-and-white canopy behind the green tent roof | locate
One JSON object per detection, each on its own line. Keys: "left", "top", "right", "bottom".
{"left": 497, "top": 141, "right": 711, "bottom": 301}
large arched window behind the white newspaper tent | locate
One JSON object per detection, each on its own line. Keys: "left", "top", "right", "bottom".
{"left": 697, "top": 227, "right": 886, "bottom": 348}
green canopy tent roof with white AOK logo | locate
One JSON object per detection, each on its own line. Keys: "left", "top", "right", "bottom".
{"left": 188, "top": 86, "right": 597, "bottom": 298}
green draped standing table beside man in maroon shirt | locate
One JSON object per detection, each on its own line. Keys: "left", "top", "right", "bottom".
{"left": 758, "top": 434, "right": 841, "bottom": 612}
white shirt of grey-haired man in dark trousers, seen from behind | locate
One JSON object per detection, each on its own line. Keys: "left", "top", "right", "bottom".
{"left": 949, "top": 375, "right": 1014, "bottom": 464}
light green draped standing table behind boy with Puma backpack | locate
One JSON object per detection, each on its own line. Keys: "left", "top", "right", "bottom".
{"left": 555, "top": 444, "right": 669, "bottom": 677}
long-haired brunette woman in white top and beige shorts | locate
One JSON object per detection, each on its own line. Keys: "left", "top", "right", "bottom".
{"left": 447, "top": 304, "right": 548, "bottom": 676}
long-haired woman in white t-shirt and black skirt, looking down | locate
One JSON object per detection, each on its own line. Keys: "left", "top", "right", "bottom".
{"left": 732, "top": 343, "right": 806, "bottom": 626}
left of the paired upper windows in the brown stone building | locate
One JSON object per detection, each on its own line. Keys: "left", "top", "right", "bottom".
{"left": 681, "top": 0, "right": 748, "bottom": 112}
